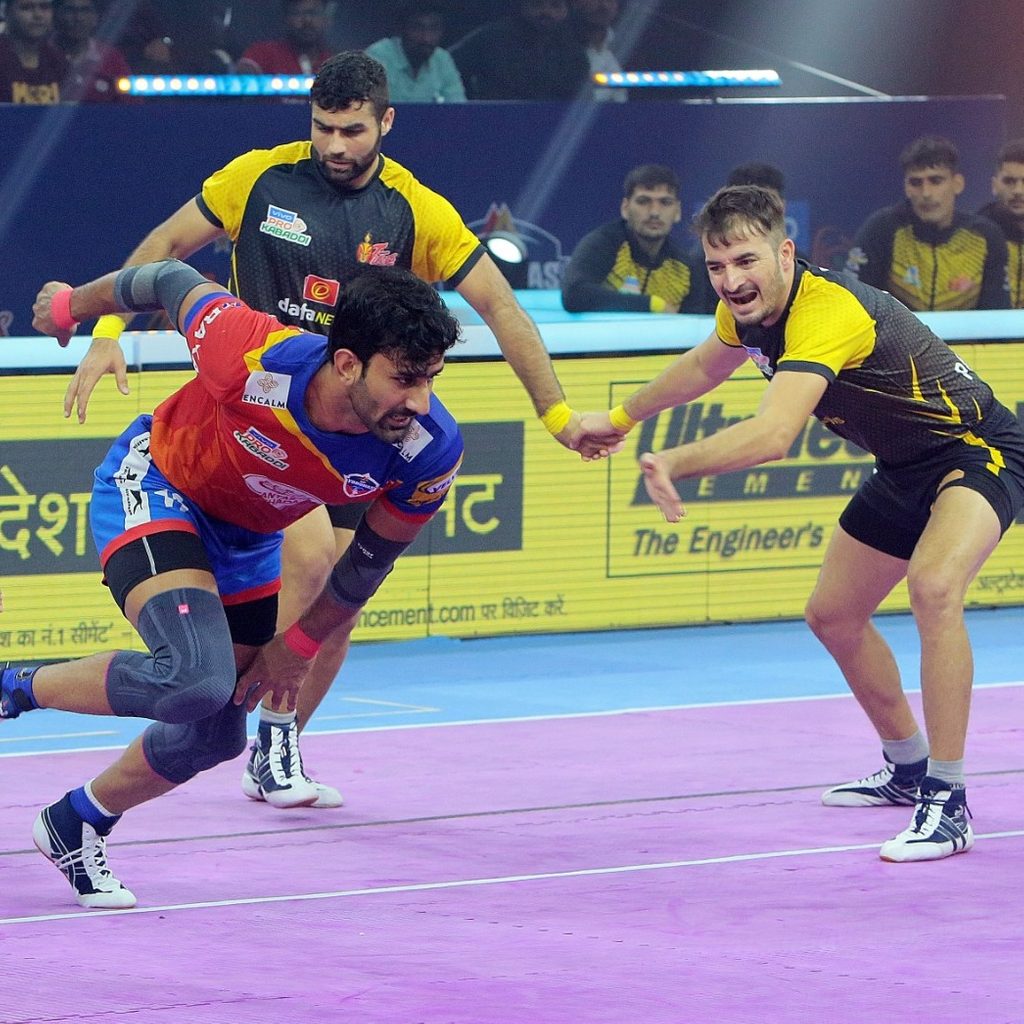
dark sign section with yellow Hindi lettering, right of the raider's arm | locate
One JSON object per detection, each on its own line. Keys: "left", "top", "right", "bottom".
{"left": 410, "top": 422, "right": 523, "bottom": 555}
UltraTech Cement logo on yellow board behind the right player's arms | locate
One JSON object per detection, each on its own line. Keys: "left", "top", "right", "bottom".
{"left": 630, "top": 401, "right": 874, "bottom": 506}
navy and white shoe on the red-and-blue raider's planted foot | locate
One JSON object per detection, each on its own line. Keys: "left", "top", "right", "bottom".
{"left": 32, "top": 797, "right": 135, "bottom": 910}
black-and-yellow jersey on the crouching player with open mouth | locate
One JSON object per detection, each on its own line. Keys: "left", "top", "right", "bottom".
{"left": 715, "top": 261, "right": 1024, "bottom": 466}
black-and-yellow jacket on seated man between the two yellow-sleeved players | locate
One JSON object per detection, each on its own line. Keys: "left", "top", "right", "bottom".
{"left": 562, "top": 220, "right": 713, "bottom": 313}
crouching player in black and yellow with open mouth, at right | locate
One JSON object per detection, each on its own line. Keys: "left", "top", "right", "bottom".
{"left": 583, "top": 185, "right": 1024, "bottom": 861}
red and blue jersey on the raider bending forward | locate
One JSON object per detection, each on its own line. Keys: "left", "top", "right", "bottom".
{"left": 151, "top": 293, "right": 463, "bottom": 532}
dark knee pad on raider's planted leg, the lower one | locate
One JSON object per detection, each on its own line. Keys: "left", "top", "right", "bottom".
{"left": 142, "top": 702, "right": 248, "bottom": 783}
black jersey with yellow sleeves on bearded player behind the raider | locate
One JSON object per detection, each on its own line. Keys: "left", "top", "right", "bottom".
{"left": 196, "top": 141, "right": 483, "bottom": 334}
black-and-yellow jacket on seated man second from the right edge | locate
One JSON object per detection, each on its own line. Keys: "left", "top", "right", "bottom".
{"left": 846, "top": 203, "right": 1010, "bottom": 310}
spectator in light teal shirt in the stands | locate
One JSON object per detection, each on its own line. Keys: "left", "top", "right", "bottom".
{"left": 367, "top": 0, "right": 466, "bottom": 103}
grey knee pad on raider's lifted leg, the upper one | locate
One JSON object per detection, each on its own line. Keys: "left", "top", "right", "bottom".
{"left": 106, "top": 587, "right": 236, "bottom": 723}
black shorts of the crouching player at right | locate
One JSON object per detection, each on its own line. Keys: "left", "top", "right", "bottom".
{"left": 839, "top": 407, "right": 1024, "bottom": 561}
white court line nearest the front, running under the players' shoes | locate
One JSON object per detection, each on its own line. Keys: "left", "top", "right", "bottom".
{"left": 8, "top": 828, "right": 1024, "bottom": 925}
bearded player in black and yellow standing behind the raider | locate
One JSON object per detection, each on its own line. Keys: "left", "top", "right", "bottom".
{"left": 65, "top": 51, "right": 580, "bottom": 807}
